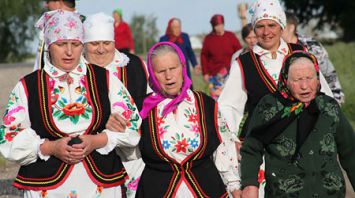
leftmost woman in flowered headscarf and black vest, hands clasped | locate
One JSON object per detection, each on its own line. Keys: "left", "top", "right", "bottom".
{"left": 0, "top": 10, "right": 141, "bottom": 197}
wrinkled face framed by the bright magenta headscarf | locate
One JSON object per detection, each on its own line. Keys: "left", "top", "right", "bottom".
{"left": 152, "top": 52, "right": 183, "bottom": 96}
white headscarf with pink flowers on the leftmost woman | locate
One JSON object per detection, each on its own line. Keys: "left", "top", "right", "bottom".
{"left": 35, "top": 10, "right": 84, "bottom": 49}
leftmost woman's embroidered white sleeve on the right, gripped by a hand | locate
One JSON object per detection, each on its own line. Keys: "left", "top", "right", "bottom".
{"left": 97, "top": 73, "right": 142, "bottom": 154}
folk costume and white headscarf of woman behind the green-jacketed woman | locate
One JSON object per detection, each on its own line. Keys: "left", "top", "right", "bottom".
{"left": 218, "top": 0, "right": 332, "bottom": 197}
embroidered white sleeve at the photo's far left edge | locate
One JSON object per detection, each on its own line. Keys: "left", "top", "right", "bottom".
{"left": 0, "top": 82, "right": 42, "bottom": 165}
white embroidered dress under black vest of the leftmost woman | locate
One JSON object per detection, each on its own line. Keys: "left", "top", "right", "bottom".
{"left": 0, "top": 56, "right": 141, "bottom": 197}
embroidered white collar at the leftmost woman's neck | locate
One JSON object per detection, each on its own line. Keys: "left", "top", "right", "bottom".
{"left": 43, "top": 56, "right": 86, "bottom": 78}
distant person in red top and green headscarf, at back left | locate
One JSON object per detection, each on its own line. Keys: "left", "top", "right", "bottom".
{"left": 112, "top": 8, "right": 134, "bottom": 53}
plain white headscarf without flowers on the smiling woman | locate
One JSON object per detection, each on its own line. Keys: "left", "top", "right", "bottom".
{"left": 84, "top": 12, "right": 115, "bottom": 43}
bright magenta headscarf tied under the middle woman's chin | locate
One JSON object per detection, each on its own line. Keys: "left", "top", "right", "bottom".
{"left": 139, "top": 42, "right": 192, "bottom": 119}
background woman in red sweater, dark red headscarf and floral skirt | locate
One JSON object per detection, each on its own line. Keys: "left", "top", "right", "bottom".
{"left": 201, "top": 14, "right": 242, "bottom": 100}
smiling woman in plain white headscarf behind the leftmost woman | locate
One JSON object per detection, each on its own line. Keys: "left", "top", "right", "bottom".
{"left": 84, "top": 13, "right": 148, "bottom": 197}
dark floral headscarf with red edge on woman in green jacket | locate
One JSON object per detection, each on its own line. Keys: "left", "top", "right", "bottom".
{"left": 277, "top": 50, "right": 319, "bottom": 101}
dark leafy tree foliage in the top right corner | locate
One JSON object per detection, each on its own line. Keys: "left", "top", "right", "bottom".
{"left": 283, "top": 0, "right": 355, "bottom": 41}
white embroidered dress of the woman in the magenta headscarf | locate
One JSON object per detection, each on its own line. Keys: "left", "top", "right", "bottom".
{"left": 138, "top": 90, "right": 240, "bottom": 198}
